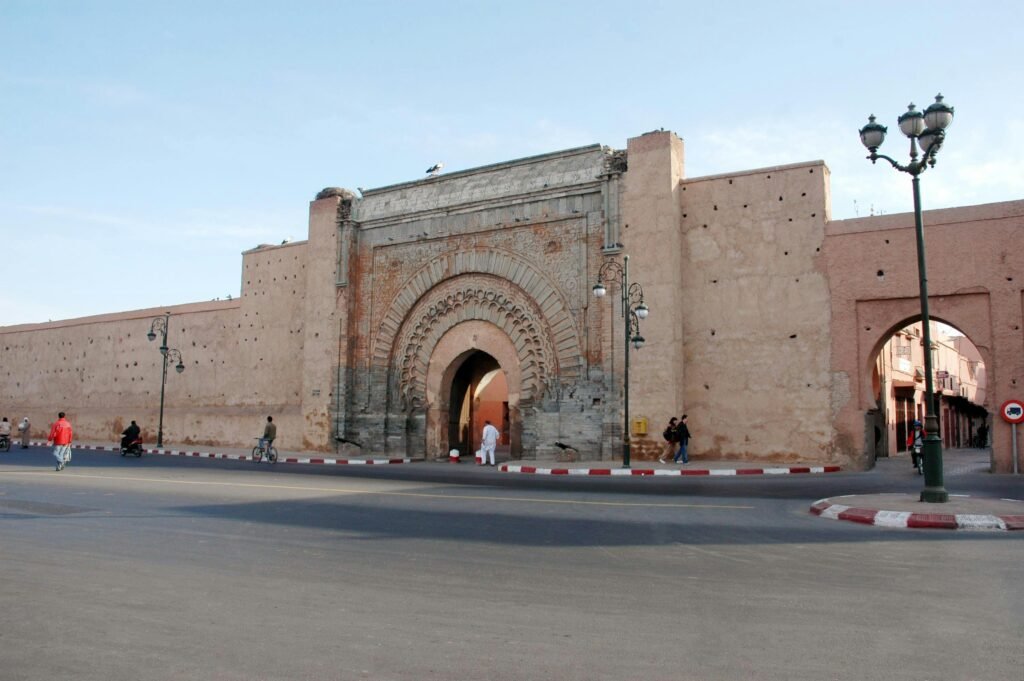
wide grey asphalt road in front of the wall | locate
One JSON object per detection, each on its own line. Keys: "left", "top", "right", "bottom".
{"left": 0, "top": 449, "right": 1024, "bottom": 681}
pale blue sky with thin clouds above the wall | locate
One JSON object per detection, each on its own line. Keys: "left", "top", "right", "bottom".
{"left": 0, "top": 0, "right": 1024, "bottom": 327}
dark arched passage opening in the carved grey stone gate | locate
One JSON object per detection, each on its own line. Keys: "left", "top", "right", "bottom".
{"left": 449, "top": 350, "right": 511, "bottom": 455}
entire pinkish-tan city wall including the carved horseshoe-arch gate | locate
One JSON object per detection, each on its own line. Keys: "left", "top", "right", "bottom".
{"left": 0, "top": 131, "right": 1024, "bottom": 471}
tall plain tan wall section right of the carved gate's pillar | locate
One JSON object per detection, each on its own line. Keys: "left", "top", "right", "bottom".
{"left": 680, "top": 162, "right": 836, "bottom": 462}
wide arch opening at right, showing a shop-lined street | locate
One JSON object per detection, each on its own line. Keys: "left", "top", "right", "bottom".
{"left": 865, "top": 317, "right": 991, "bottom": 458}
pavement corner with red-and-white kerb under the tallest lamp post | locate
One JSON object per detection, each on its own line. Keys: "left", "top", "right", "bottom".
{"left": 810, "top": 494, "right": 1024, "bottom": 531}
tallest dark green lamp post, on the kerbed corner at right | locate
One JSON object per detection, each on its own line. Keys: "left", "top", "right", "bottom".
{"left": 860, "top": 94, "right": 953, "bottom": 503}
